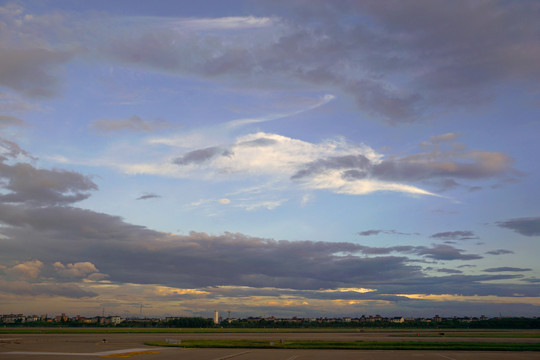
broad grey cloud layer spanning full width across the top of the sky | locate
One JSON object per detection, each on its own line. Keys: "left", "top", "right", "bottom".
{"left": 4, "top": 0, "right": 540, "bottom": 124}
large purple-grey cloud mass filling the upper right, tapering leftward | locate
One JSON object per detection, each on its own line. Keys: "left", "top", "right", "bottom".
{"left": 99, "top": 1, "right": 540, "bottom": 124}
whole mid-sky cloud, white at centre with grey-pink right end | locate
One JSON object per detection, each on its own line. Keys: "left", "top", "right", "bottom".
{"left": 103, "top": 129, "right": 515, "bottom": 202}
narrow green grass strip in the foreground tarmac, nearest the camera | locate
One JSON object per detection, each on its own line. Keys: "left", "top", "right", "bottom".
{"left": 145, "top": 340, "right": 540, "bottom": 351}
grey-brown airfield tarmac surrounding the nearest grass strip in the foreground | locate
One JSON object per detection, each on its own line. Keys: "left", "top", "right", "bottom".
{"left": 0, "top": 333, "right": 540, "bottom": 360}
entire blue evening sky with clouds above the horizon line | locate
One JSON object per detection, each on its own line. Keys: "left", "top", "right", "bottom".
{"left": 0, "top": 0, "right": 540, "bottom": 317}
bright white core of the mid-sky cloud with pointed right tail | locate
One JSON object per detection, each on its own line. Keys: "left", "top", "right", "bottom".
{"left": 166, "top": 132, "right": 432, "bottom": 195}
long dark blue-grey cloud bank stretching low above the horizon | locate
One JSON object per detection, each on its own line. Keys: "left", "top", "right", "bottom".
{"left": 0, "top": 197, "right": 539, "bottom": 299}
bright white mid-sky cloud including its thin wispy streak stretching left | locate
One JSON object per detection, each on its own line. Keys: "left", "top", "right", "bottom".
{"left": 106, "top": 132, "right": 434, "bottom": 200}
